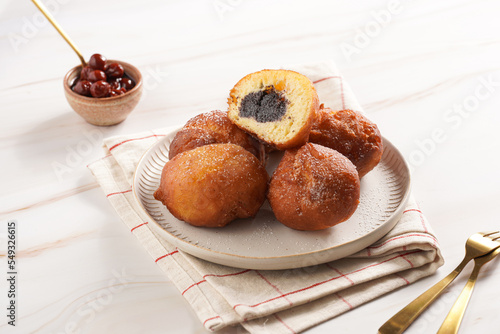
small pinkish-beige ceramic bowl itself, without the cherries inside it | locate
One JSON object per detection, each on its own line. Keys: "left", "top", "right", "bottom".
{"left": 64, "top": 60, "right": 142, "bottom": 126}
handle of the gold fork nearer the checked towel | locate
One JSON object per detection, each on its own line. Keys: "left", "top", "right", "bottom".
{"left": 378, "top": 257, "right": 471, "bottom": 334}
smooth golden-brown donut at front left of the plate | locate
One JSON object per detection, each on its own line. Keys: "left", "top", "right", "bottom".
{"left": 154, "top": 144, "right": 268, "bottom": 227}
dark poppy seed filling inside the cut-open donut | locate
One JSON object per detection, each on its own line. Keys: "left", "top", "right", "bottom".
{"left": 240, "top": 86, "right": 289, "bottom": 123}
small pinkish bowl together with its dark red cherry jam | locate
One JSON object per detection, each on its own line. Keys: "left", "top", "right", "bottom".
{"left": 64, "top": 58, "right": 143, "bottom": 126}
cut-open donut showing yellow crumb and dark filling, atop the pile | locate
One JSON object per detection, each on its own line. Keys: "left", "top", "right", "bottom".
{"left": 228, "top": 70, "right": 319, "bottom": 150}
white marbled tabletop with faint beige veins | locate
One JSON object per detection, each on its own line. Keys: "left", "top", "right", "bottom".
{"left": 0, "top": 0, "right": 500, "bottom": 334}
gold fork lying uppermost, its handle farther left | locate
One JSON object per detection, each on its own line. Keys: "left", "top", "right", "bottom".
{"left": 378, "top": 231, "right": 500, "bottom": 334}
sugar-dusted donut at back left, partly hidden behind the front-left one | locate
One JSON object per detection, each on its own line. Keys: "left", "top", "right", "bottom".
{"left": 168, "top": 110, "right": 263, "bottom": 159}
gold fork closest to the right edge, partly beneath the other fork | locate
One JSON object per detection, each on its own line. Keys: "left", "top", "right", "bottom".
{"left": 437, "top": 245, "right": 500, "bottom": 334}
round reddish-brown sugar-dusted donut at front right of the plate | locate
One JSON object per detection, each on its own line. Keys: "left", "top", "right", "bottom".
{"left": 267, "top": 143, "right": 360, "bottom": 231}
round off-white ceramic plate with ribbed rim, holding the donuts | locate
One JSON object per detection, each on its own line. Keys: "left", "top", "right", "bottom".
{"left": 133, "top": 131, "right": 410, "bottom": 270}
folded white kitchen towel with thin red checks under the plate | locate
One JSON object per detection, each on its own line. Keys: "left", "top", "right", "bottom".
{"left": 88, "top": 62, "right": 443, "bottom": 334}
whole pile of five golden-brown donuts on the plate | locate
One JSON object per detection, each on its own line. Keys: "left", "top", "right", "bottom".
{"left": 154, "top": 70, "right": 383, "bottom": 231}
